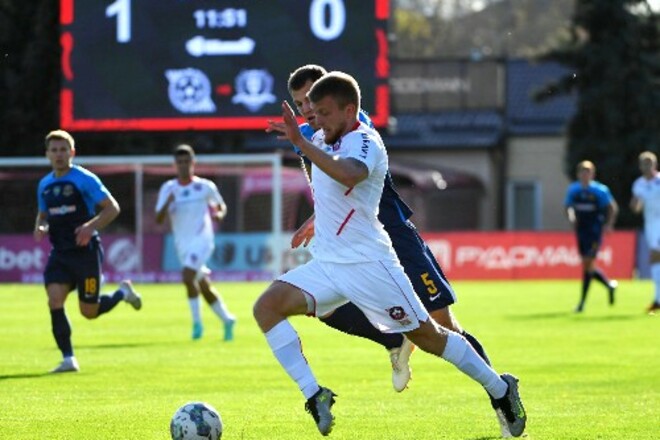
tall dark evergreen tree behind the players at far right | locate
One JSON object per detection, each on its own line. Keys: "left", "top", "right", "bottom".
{"left": 535, "top": 0, "right": 660, "bottom": 227}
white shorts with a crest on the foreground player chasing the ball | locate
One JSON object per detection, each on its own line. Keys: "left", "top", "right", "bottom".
{"left": 278, "top": 260, "right": 429, "bottom": 333}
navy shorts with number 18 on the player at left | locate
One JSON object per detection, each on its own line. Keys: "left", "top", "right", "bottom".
{"left": 44, "top": 242, "right": 103, "bottom": 304}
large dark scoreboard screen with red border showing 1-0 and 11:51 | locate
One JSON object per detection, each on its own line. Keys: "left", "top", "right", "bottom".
{"left": 60, "top": 0, "right": 389, "bottom": 131}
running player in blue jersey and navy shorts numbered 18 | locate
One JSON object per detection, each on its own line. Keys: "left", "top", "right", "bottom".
{"left": 34, "top": 130, "right": 142, "bottom": 373}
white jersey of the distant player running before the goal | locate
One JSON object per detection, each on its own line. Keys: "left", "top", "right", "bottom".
{"left": 156, "top": 176, "right": 224, "bottom": 252}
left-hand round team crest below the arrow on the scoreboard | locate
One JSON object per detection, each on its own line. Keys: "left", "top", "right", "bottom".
{"left": 165, "top": 68, "right": 215, "bottom": 113}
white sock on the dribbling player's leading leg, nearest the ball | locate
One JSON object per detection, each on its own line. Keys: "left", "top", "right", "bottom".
{"left": 265, "top": 320, "right": 319, "bottom": 399}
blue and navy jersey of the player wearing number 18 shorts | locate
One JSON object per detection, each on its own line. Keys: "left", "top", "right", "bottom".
{"left": 37, "top": 165, "right": 110, "bottom": 250}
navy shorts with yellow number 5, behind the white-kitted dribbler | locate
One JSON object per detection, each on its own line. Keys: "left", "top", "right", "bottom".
{"left": 387, "top": 221, "right": 456, "bottom": 312}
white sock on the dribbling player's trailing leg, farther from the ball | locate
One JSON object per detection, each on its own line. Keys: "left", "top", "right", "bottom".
{"left": 442, "top": 331, "right": 507, "bottom": 399}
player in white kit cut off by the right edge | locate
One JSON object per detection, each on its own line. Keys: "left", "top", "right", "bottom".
{"left": 630, "top": 151, "right": 660, "bottom": 313}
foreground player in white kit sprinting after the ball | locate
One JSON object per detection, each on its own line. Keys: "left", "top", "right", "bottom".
{"left": 253, "top": 72, "right": 526, "bottom": 436}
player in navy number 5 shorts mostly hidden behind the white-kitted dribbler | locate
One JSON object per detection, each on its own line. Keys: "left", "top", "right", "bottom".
{"left": 288, "top": 65, "right": 510, "bottom": 436}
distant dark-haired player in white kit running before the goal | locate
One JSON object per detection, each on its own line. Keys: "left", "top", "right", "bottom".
{"left": 156, "top": 145, "right": 236, "bottom": 341}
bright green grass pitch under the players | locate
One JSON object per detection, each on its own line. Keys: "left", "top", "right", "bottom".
{"left": 0, "top": 280, "right": 660, "bottom": 440}
